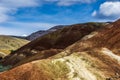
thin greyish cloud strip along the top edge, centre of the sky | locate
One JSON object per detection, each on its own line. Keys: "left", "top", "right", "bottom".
{"left": 46, "top": 0, "right": 96, "bottom": 6}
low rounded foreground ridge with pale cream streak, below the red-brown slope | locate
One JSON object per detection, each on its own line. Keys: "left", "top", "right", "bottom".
{"left": 0, "top": 50, "right": 120, "bottom": 80}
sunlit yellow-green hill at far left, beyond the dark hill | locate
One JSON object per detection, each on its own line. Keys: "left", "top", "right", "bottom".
{"left": 0, "top": 35, "right": 29, "bottom": 57}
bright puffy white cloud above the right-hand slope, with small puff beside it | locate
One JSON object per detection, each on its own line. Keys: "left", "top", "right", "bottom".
{"left": 92, "top": 1, "right": 120, "bottom": 19}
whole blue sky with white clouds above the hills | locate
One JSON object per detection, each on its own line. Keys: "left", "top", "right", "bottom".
{"left": 0, "top": 0, "right": 120, "bottom": 36}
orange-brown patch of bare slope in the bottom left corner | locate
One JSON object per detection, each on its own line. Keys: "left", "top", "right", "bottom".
{"left": 0, "top": 63, "right": 45, "bottom": 80}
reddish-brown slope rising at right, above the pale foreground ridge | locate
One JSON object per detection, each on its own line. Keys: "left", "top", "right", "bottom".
{"left": 71, "top": 20, "right": 120, "bottom": 55}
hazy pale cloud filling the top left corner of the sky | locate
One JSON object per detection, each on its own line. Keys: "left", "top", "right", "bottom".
{"left": 0, "top": 0, "right": 38, "bottom": 23}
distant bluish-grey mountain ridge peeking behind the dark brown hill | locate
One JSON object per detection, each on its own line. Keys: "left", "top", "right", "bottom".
{"left": 26, "top": 25, "right": 65, "bottom": 41}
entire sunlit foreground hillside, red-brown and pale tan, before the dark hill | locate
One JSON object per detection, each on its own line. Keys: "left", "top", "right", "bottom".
{"left": 0, "top": 20, "right": 120, "bottom": 80}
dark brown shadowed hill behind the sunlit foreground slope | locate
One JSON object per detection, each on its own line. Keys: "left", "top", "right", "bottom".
{"left": 1, "top": 23, "right": 105, "bottom": 65}
